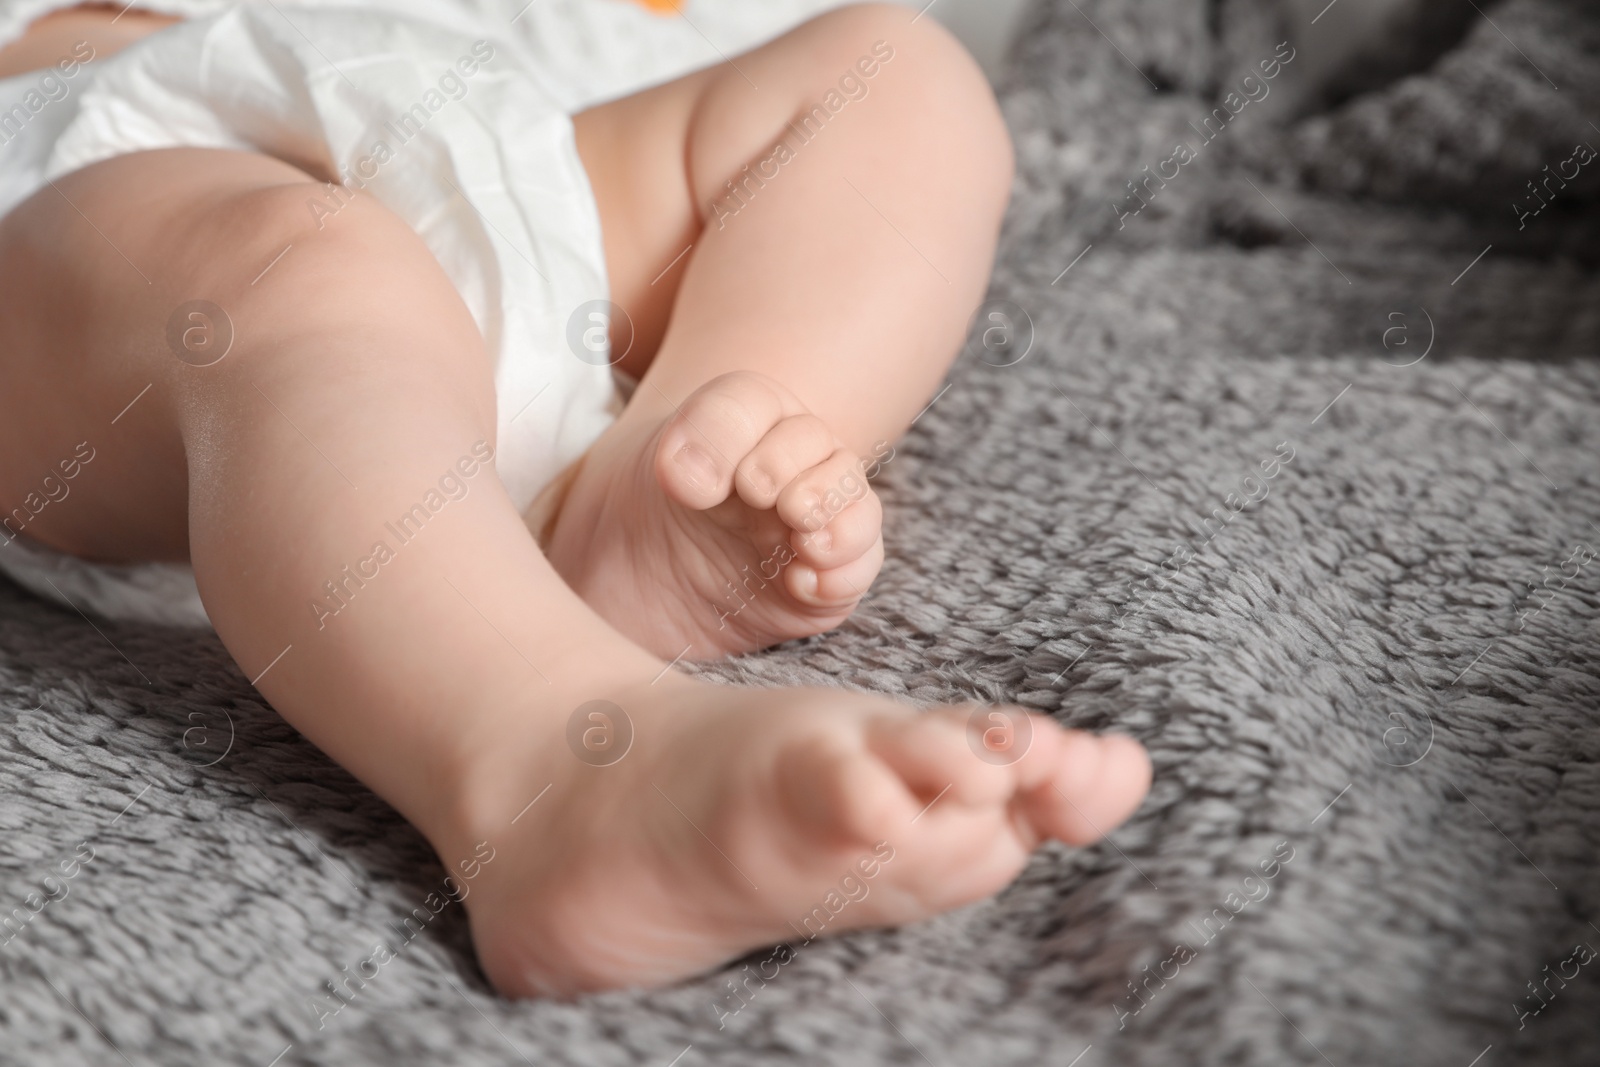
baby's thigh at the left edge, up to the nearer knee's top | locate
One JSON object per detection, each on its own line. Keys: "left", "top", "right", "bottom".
{"left": 0, "top": 149, "right": 466, "bottom": 560}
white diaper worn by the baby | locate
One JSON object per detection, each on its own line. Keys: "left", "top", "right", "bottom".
{"left": 0, "top": 0, "right": 876, "bottom": 625}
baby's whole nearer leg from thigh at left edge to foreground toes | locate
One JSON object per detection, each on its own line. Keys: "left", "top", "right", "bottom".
{"left": 0, "top": 139, "right": 1149, "bottom": 991}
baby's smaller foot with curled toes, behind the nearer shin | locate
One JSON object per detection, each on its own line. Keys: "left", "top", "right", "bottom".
{"left": 546, "top": 371, "right": 883, "bottom": 659}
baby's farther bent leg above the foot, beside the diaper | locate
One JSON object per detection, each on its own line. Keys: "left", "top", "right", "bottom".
{"left": 576, "top": 5, "right": 1011, "bottom": 441}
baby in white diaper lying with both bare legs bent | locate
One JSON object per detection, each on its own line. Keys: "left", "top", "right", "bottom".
{"left": 0, "top": 0, "right": 1150, "bottom": 997}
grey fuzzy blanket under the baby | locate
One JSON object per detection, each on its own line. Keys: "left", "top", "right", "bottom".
{"left": 0, "top": 0, "right": 1600, "bottom": 1067}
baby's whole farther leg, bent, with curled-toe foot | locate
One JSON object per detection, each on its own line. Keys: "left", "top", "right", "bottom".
{"left": 549, "top": 5, "right": 1011, "bottom": 657}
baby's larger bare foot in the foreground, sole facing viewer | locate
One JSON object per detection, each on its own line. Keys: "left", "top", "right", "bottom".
{"left": 446, "top": 675, "right": 1150, "bottom": 998}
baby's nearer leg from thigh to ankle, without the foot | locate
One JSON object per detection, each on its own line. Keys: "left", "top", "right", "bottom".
{"left": 0, "top": 149, "right": 659, "bottom": 859}
